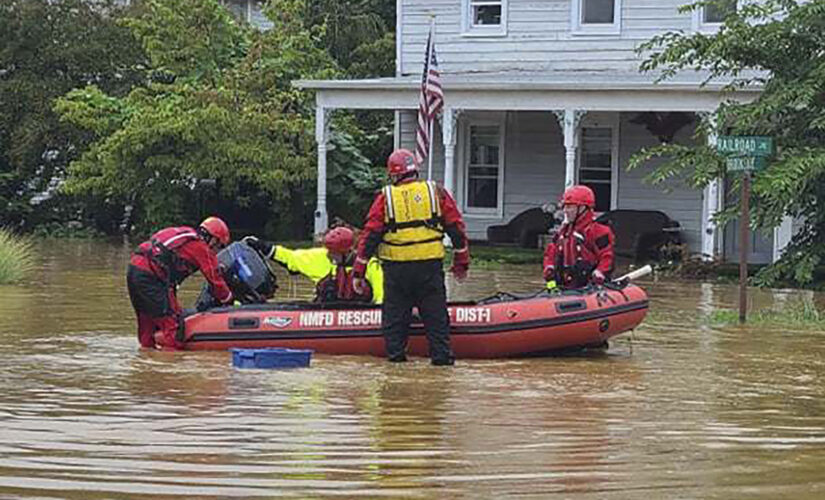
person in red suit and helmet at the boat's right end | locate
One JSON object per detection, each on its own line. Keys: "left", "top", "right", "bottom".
{"left": 544, "top": 185, "right": 614, "bottom": 290}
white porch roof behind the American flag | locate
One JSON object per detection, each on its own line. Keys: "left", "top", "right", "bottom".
{"left": 293, "top": 72, "right": 760, "bottom": 111}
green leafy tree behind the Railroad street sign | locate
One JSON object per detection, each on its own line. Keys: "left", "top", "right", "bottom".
{"left": 630, "top": 0, "right": 825, "bottom": 284}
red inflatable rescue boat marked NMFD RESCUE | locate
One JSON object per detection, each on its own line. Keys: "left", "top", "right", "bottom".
{"left": 184, "top": 284, "right": 648, "bottom": 358}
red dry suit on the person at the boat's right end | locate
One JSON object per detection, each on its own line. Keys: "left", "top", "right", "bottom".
{"left": 544, "top": 209, "right": 614, "bottom": 288}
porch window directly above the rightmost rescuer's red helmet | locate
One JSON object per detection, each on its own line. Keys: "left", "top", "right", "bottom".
{"left": 579, "top": 127, "right": 614, "bottom": 212}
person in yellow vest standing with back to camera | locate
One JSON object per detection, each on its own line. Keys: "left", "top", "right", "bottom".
{"left": 353, "top": 149, "right": 470, "bottom": 365}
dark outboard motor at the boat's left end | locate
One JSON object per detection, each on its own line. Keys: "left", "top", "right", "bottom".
{"left": 195, "top": 241, "right": 278, "bottom": 311}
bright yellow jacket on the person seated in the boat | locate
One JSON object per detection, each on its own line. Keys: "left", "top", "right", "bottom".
{"left": 271, "top": 245, "right": 384, "bottom": 304}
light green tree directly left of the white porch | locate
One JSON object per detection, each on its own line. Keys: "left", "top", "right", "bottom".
{"left": 56, "top": 0, "right": 335, "bottom": 235}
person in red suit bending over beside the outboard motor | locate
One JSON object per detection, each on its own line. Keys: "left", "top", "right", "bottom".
{"left": 126, "top": 217, "right": 232, "bottom": 350}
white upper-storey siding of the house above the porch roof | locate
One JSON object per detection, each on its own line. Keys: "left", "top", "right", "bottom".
{"left": 401, "top": 0, "right": 691, "bottom": 79}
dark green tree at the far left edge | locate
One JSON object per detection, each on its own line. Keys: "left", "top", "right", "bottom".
{"left": 0, "top": 0, "right": 144, "bottom": 229}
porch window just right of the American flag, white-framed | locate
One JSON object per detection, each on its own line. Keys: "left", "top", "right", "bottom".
{"left": 464, "top": 122, "right": 504, "bottom": 215}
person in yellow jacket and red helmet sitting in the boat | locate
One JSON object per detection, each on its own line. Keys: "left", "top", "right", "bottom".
{"left": 243, "top": 226, "right": 384, "bottom": 304}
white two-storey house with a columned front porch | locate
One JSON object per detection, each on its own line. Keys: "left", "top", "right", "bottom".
{"left": 286, "top": 0, "right": 791, "bottom": 263}
